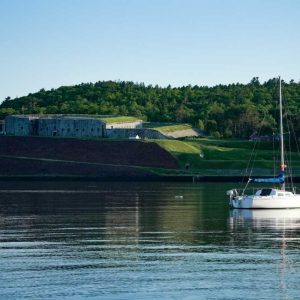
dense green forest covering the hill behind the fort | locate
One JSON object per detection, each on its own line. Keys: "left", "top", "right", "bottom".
{"left": 0, "top": 77, "right": 300, "bottom": 138}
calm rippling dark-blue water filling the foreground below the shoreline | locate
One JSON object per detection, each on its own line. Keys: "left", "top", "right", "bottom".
{"left": 0, "top": 182, "right": 300, "bottom": 299}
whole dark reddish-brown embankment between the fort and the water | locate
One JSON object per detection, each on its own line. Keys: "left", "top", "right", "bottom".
{"left": 0, "top": 136, "right": 178, "bottom": 180}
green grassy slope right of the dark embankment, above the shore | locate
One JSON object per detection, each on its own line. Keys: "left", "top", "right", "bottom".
{"left": 155, "top": 139, "right": 300, "bottom": 175}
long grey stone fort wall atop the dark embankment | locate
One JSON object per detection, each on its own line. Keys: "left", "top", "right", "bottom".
{"left": 5, "top": 115, "right": 172, "bottom": 139}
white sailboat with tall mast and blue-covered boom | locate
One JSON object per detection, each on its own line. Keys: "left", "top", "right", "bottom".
{"left": 227, "top": 77, "right": 300, "bottom": 209}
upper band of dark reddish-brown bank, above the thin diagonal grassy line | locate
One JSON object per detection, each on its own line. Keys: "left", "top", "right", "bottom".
{"left": 0, "top": 136, "right": 177, "bottom": 169}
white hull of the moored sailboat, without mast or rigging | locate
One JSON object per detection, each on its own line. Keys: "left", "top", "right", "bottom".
{"left": 230, "top": 194, "right": 300, "bottom": 209}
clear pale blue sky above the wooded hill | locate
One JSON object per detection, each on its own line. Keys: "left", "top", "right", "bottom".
{"left": 0, "top": 0, "right": 300, "bottom": 101}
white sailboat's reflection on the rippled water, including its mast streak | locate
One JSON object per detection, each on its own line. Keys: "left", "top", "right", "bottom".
{"left": 228, "top": 209, "right": 300, "bottom": 299}
